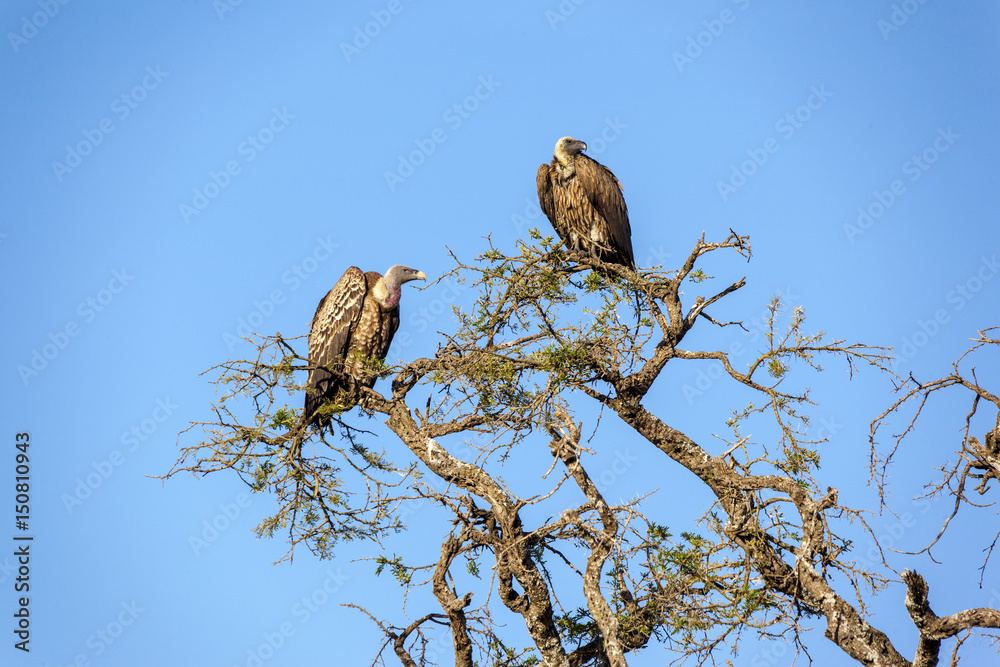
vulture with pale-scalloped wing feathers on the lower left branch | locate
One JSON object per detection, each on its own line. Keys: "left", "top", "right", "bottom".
{"left": 305, "top": 264, "right": 427, "bottom": 420}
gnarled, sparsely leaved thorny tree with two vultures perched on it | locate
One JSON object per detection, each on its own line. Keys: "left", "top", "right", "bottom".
{"left": 166, "top": 232, "right": 1000, "bottom": 667}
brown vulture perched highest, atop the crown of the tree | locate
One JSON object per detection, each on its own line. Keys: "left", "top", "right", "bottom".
{"left": 535, "top": 137, "right": 635, "bottom": 270}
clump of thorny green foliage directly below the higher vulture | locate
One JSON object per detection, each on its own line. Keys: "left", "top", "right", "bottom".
{"left": 428, "top": 236, "right": 654, "bottom": 434}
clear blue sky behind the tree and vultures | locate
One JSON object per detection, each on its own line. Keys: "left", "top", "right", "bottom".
{"left": 0, "top": 0, "right": 1000, "bottom": 667}
